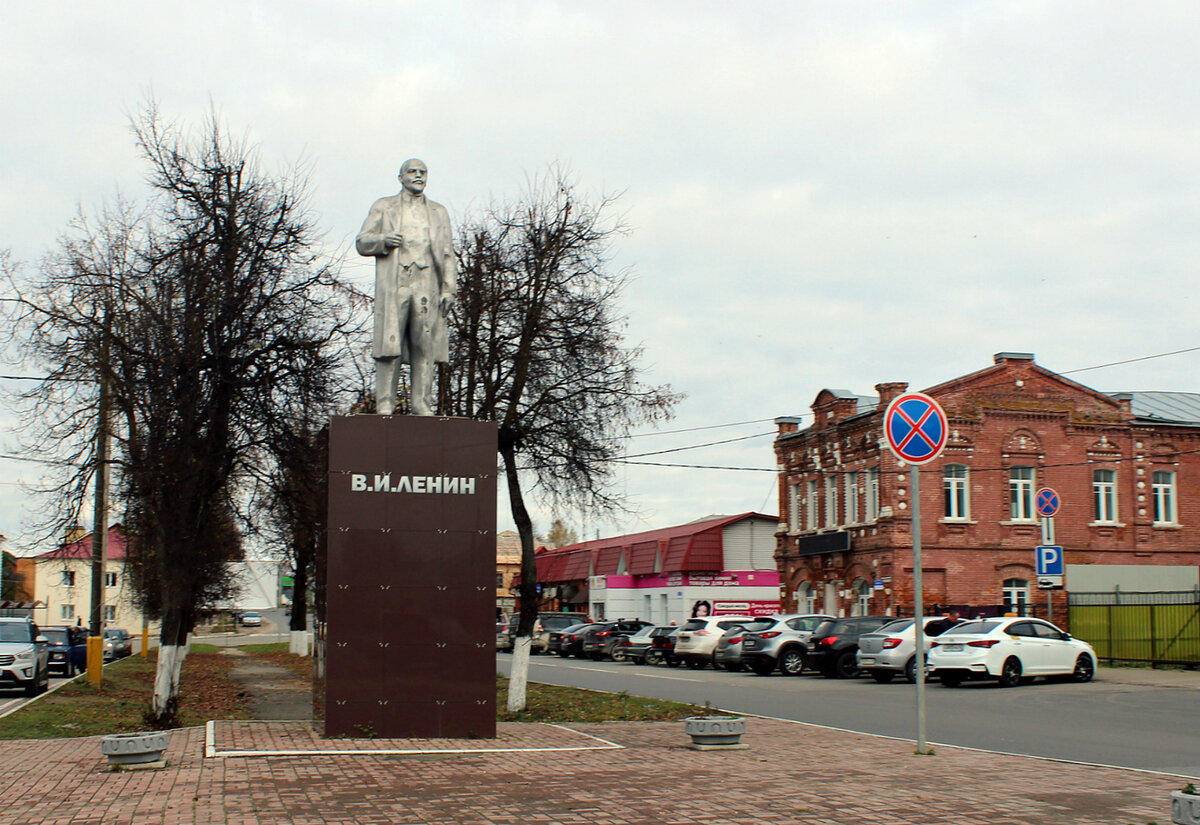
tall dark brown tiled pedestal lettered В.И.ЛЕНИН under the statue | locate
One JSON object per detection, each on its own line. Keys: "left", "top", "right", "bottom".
{"left": 324, "top": 415, "right": 496, "bottom": 739}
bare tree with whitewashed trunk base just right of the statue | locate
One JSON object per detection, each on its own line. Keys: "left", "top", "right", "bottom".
{"left": 445, "top": 170, "right": 679, "bottom": 710}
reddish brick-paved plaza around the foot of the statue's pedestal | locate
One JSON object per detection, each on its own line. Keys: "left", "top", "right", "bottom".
{"left": 0, "top": 718, "right": 1181, "bottom": 825}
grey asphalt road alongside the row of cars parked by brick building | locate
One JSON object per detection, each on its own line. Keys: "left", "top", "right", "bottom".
{"left": 497, "top": 654, "right": 1200, "bottom": 776}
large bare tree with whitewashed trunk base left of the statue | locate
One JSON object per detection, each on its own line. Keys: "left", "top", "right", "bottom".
{"left": 8, "top": 103, "right": 347, "bottom": 724}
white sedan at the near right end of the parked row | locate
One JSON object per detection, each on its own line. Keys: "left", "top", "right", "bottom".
{"left": 929, "top": 616, "right": 1096, "bottom": 687}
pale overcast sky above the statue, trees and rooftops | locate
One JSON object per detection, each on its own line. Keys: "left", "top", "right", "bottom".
{"left": 0, "top": 0, "right": 1200, "bottom": 549}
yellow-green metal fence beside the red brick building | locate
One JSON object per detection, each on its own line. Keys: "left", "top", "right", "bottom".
{"left": 1068, "top": 590, "right": 1200, "bottom": 666}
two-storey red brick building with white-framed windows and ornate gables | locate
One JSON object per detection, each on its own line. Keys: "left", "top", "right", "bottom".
{"left": 775, "top": 353, "right": 1200, "bottom": 615}
